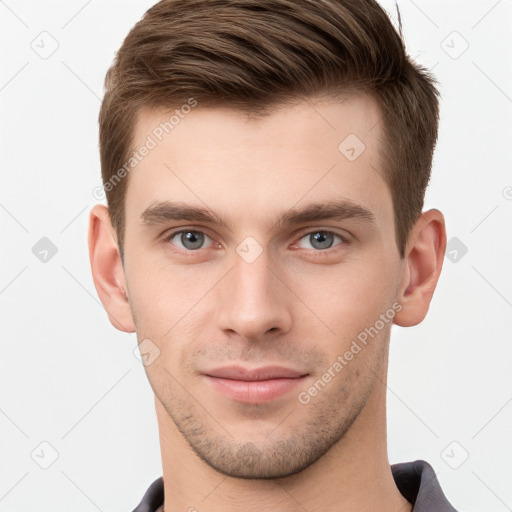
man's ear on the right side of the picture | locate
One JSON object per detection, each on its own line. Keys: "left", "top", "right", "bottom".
{"left": 394, "top": 210, "right": 446, "bottom": 327}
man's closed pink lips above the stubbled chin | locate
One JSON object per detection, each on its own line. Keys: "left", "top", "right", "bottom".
{"left": 203, "top": 366, "right": 309, "bottom": 404}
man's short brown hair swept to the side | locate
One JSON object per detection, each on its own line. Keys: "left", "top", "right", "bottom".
{"left": 99, "top": 0, "right": 439, "bottom": 258}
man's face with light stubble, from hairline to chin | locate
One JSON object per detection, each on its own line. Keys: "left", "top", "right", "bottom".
{"left": 124, "top": 96, "right": 401, "bottom": 478}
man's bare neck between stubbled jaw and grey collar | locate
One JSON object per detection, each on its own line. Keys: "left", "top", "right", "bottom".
{"left": 155, "top": 368, "right": 412, "bottom": 512}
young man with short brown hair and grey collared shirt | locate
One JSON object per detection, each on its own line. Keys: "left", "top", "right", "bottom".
{"left": 89, "top": 0, "right": 454, "bottom": 512}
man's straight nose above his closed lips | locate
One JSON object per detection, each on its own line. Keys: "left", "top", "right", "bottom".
{"left": 213, "top": 246, "right": 292, "bottom": 342}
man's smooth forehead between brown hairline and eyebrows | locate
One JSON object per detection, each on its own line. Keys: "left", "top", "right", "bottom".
{"left": 126, "top": 96, "right": 391, "bottom": 230}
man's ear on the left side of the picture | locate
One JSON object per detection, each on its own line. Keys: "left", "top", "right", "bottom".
{"left": 89, "top": 204, "right": 135, "bottom": 332}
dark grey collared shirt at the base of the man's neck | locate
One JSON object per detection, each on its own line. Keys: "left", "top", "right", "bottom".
{"left": 133, "top": 460, "right": 457, "bottom": 512}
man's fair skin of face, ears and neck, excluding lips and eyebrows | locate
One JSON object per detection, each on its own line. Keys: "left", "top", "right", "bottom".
{"left": 89, "top": 96, "right": 446, "bottom": 512}
